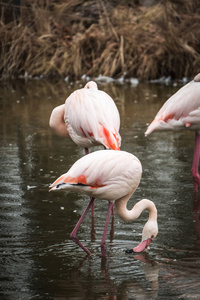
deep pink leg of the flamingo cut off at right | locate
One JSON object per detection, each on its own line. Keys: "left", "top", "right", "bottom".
{"left": 191, "top": 133, "right": 200, "bottom": 191}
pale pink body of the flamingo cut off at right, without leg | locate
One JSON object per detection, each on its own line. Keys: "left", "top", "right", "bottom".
{"left": 145, "top": 81, "right": 200, "bottom": 135}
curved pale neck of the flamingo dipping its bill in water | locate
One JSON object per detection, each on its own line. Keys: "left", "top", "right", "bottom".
{"left": 115, "top": 195, "right": 157, "bottom": 221}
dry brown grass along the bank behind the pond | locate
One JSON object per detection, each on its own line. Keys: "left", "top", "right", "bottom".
{"left": 0, "top": 0, "right": 200, "bottom": 80}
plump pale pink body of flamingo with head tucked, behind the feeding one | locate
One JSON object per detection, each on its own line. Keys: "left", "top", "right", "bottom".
{"left": 49, "top": 81, "right": 121, "bottom": 153}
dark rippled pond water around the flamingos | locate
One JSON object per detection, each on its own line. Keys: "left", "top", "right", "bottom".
{"left": 0, "top": 81, "right": 200, "bottom": 300}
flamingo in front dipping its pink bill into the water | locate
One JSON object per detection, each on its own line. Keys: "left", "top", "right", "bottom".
{"left": 50, "top": 150, "right": 158, "bottom": 256}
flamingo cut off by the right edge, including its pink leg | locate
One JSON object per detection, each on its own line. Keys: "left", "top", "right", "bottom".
{"left": 145, "top": 73, "right": 200, "bottom": 191}
